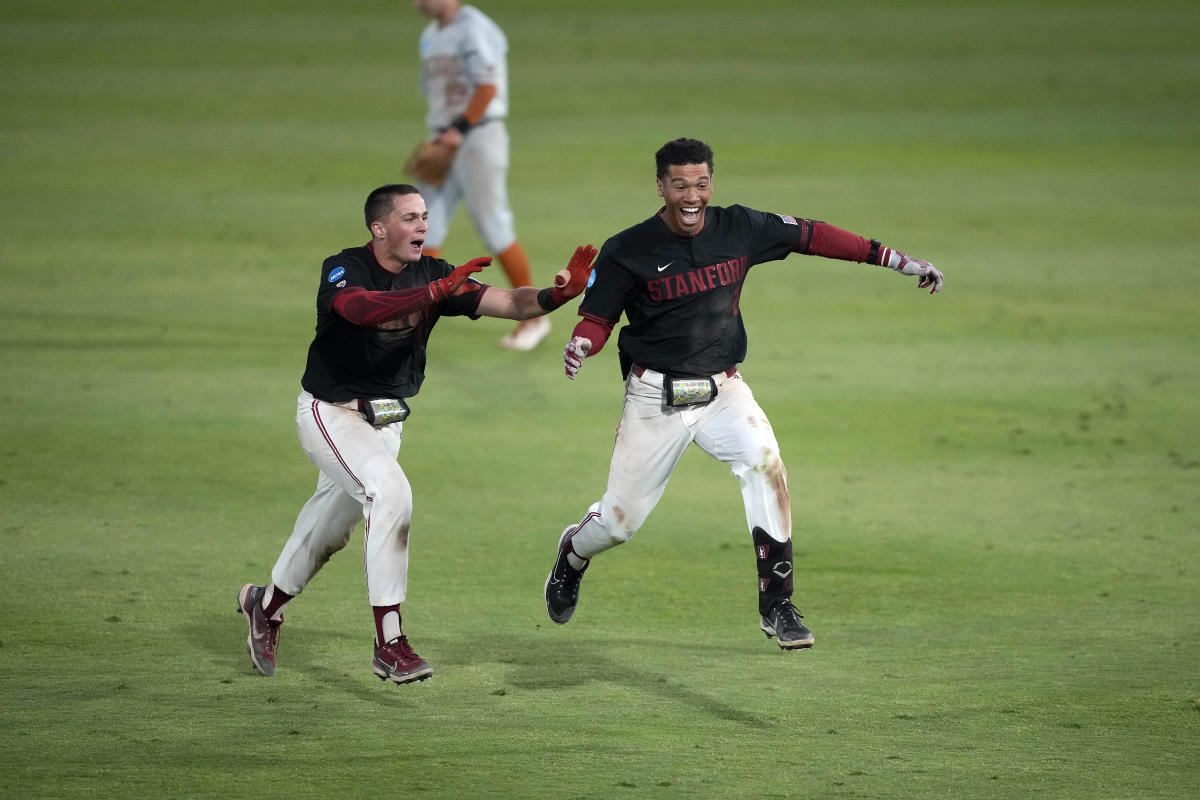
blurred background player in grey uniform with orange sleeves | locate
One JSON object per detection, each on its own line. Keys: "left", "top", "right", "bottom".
{"left": 413, "top": 0, "right": 550, "bottom": 350}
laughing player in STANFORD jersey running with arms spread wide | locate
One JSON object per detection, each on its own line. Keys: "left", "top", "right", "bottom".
{"left": 545, "top": 139, "right": 942, "bottom": 650}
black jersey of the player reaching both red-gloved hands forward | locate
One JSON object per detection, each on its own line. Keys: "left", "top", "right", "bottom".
{"left": 300, "top": 247, "right": 484, "bottom": 402}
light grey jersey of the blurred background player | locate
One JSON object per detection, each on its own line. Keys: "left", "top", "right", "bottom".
{"left": 419, "top": 6, "right": 509, "bottom": 131}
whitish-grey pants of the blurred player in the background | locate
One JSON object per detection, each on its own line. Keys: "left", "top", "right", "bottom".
{"left": 418, "top": 120, "right": 517, "bottom": 253}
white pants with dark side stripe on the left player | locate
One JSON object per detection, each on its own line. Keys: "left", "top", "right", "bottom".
{"left": 271, "top": 392, "right": 413, "bottom": 606}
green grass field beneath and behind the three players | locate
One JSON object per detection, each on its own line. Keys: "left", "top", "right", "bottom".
{"left": 0, "top": 0, "right": 1200, "bottom": 800}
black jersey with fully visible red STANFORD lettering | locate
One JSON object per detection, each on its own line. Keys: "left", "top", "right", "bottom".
{"left": 580, "top": 205, "right": 811, "bottom": 375}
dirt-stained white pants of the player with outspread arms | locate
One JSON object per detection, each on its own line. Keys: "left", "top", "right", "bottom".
{"left": 571, "top": 369, "right": 792, "bottom": 558}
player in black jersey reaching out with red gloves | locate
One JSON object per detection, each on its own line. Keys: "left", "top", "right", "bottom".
{"left": 238, "top": 184, "right": 595, "bottom": 684}
